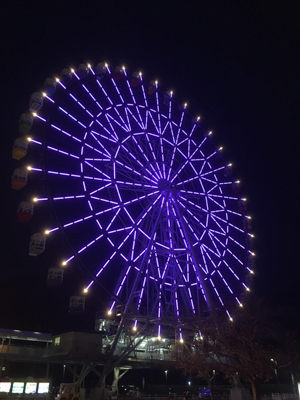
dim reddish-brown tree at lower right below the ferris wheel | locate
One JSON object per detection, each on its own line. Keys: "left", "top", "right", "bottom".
{"left": 179, "top": 297, "right": 276, "bottom": 400}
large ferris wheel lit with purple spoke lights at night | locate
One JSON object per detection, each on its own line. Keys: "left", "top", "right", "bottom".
{"left": 13, "top": 63, "right": 254, "bottom": 337}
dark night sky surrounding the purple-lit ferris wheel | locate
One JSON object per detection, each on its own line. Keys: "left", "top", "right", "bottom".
{"left": 0, "top": 0, "right": 300, "bottom": 330}
